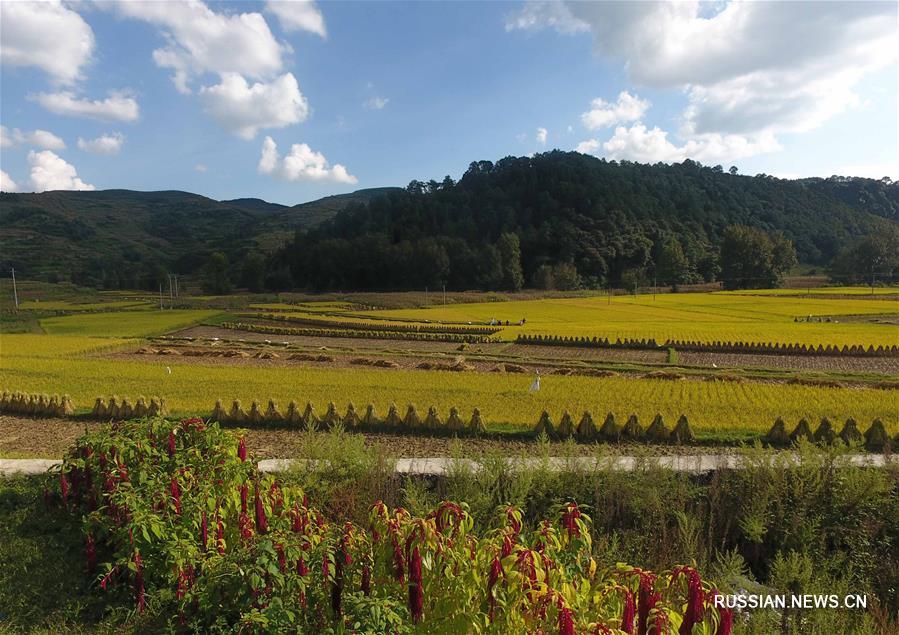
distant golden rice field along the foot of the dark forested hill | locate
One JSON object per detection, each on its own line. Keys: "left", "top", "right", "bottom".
{"left": 366, "top": 293, "right": 899, "bottom": 346}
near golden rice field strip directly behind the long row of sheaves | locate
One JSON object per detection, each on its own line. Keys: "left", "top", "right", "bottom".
{"left": 0, "top": 335, "right": 899, "bottom": 435}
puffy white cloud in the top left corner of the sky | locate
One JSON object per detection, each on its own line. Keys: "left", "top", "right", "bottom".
{"left": 0, "top": 0, "right": 94, "bottom": 84}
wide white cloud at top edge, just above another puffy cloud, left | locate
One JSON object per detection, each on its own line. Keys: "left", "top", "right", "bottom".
{"left": 110, "top": 0, "right": 291, "bottom": 93}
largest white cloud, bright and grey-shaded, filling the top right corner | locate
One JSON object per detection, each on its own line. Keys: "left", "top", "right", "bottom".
{"left": 510, "top": 1, "right": 897, "bottom": 142}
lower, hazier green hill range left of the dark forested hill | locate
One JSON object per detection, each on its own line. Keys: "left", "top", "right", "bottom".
{"left": 0, "top": 188, "right": 392, "bottom": 289}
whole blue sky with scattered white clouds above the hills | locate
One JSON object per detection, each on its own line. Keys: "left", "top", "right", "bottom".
{"left": 0, "top": 1, "right": 899, "bottom": 204}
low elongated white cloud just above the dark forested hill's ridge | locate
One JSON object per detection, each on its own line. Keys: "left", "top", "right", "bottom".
{"left": 596, "top": 123, "right": 781, "bottom": 163}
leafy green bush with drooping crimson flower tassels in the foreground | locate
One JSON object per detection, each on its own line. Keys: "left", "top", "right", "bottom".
{"left": 59, "top": 419, "right": 732, "bottom": 635}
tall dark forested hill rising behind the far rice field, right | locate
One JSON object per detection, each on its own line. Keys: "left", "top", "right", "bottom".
{"left": 282, "top": 151, "right": 899, "bottom": 289}
